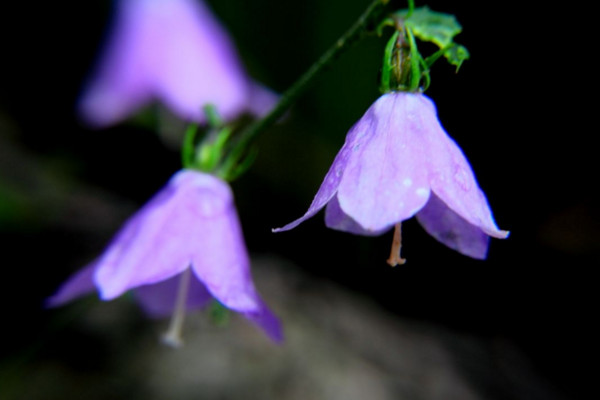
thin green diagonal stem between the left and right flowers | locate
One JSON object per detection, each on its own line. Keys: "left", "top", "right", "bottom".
{"left": 224, "top": 0, "right": 390, "bottom": 178}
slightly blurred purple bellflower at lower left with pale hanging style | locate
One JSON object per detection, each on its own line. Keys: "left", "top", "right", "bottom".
{"left": 48, "top": 169, "right": 282, "bottom": 344}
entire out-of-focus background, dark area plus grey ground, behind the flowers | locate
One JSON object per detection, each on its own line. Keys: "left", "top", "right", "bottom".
{"left": 0, "top": 0, "right": 600, "bottom": 400}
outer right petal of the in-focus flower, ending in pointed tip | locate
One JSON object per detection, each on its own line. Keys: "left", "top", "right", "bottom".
{"left": 412, "top": 95, "right": 508, "bottom": 239}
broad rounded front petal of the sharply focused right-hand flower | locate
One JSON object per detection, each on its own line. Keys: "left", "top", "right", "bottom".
{"left": 337, "top": 93, "right": 429, "bottom": 232}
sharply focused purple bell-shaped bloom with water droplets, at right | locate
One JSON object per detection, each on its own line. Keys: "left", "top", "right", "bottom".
{"left": 274, "top": 92, "right": 508, "bottom": 259}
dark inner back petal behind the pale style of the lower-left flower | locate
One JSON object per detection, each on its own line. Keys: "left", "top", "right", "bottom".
{"left": 134, "top": 274, "right": 213, "bottom": 318}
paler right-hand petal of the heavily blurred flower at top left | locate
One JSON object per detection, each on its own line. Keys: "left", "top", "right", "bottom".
{"left": 155, "top": 0, "right": 251, "bottom": 121}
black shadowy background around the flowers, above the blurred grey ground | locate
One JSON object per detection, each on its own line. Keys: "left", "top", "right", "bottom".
{"left": 0, "top": 0, "right": 600, "bottom": 398}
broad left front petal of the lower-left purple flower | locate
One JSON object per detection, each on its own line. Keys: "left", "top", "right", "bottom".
{"left": 95, "top": 170, "right": 231, "bottom": 300}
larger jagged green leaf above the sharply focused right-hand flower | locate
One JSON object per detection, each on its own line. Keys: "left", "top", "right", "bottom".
{"left": 397, "top": 6, "right": 462, "bottom": 49}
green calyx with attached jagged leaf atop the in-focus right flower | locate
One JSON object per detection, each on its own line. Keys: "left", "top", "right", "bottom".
{"left": 378, "top": 5, "right": 469, "bottom": 93}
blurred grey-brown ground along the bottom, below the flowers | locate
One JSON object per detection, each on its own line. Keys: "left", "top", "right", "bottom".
{"left": 0, "top": 256, "right": 561, "bottom": 400}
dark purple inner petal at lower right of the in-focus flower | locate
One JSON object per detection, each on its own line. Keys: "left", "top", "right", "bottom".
{"left": 417, "top": 194, "right": 490, "bottom": 259}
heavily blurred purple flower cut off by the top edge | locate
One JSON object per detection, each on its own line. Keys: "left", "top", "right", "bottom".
{"left": 79, "top": 0, "right": 276, "bottom": 127}
